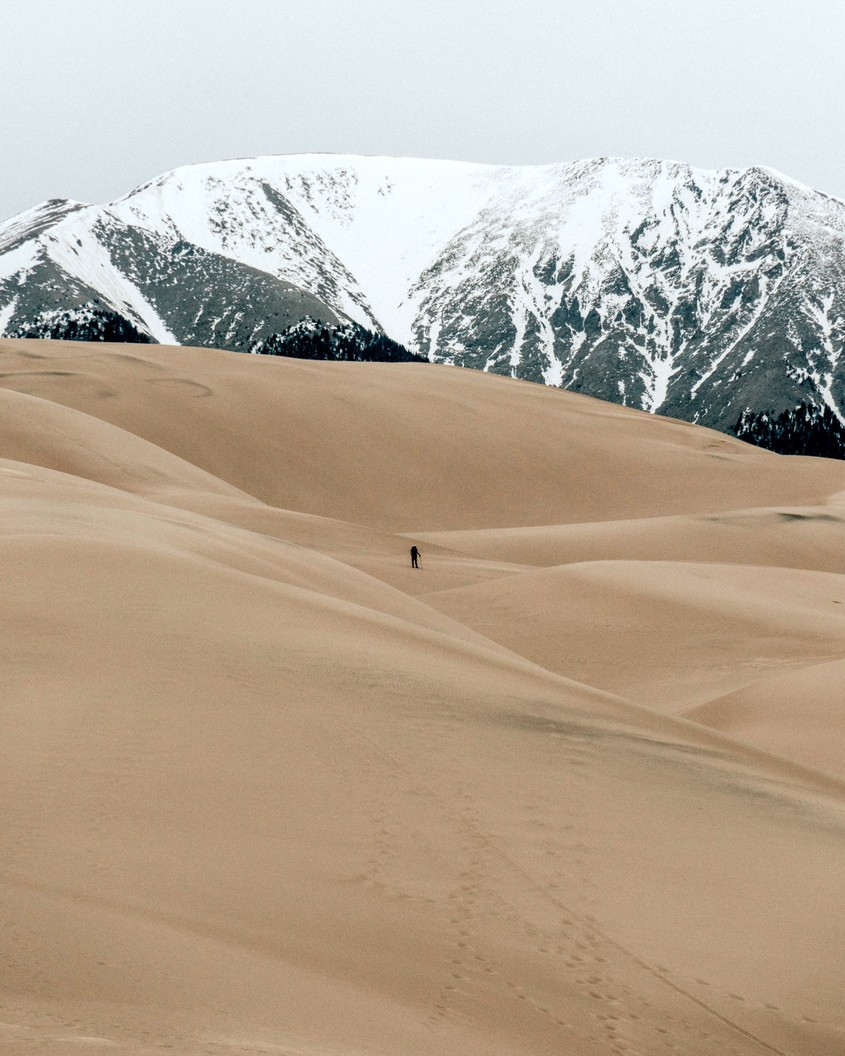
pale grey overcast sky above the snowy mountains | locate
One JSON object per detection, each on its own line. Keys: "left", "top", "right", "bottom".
{"left": 0, "top": 0, "right": 845, "bottom": 219}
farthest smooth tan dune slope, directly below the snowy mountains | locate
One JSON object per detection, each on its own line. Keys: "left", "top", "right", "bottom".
{"left": 0, "top": 341, "right": 845, "bottom": 532}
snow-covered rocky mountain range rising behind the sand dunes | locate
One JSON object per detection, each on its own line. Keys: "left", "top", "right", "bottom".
{"left": 0, "top": 155, "right": 845, "bottom": 429}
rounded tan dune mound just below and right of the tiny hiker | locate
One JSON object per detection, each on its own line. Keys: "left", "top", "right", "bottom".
{"left": 425, "top": 561, "right": 845, "bottom": 713}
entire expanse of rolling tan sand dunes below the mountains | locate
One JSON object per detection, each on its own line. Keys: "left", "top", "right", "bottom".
{"left": 0, "top": 341, "right": 845, "bottom": 1056}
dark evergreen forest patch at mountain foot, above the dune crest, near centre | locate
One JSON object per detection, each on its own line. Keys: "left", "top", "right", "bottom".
{"left": 249, "top": 319, "right": 428, "bottom": 363}
